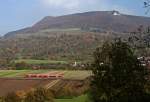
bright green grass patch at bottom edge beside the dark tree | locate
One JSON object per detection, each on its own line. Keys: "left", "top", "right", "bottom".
{"left": 55, "top": 95, "right": 87, "bottom": 102}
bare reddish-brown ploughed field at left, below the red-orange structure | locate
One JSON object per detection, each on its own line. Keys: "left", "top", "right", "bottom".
{"left": 0, "top": 79, "right": 52, "bottom": 96}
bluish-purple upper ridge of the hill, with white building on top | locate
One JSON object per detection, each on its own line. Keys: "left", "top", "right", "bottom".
{"left": 6, "top": 11, "right": 150, "bottom": 36}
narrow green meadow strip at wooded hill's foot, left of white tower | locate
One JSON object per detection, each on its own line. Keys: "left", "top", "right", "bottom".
{"left": 15, "top": 59, "right": 68, "bottom": 64}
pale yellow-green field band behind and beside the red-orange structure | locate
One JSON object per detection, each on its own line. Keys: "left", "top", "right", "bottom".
{"left": 0, "top": 70, "right": 91, "bottom": 80}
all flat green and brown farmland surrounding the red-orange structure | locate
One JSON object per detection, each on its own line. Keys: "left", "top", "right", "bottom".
{"left": 0, "top": 70, "right": 91, "bottom": 96}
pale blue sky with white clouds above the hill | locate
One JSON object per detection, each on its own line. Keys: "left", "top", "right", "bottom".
{"left": 0, "top": 0, "right": 150, "bottom": 35}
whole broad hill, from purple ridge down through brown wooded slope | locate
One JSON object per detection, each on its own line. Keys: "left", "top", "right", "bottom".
{"left": 0, "top": 11, "right": 150, "bottom": 61}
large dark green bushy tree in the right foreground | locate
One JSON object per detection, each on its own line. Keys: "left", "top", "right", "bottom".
{"left": 91, "top": 39, "right": 150, "bottom": 102}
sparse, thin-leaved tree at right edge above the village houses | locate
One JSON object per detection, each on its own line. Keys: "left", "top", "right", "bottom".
{"left": 128, "top": 25, "right": 150, "bottom": 56}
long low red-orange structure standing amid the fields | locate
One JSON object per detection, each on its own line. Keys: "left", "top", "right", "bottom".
{"left": 26, "top": 72, "right": 64, "bottom": 78}
